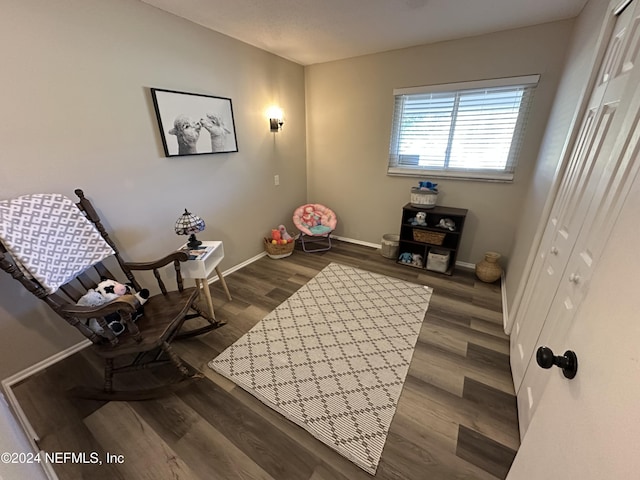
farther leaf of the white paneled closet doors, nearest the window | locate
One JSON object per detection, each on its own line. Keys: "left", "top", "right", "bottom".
{"left": 511, "top": 0, "right": 633, "bottom": 391}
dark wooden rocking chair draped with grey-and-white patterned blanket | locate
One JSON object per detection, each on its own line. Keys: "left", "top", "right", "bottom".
{"left": 0, "top": 190, "right": 222, "bottom": 400}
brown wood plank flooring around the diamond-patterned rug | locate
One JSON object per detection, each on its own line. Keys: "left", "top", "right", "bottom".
{"left": 8, "top": 241, "right": 519, "bottom": 480}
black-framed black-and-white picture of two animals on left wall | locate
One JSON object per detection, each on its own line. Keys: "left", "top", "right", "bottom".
{"left": 151, "top": 88, "right": 238, "bottom": 157}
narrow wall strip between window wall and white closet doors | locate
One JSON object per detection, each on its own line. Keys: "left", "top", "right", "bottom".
{"left": 506, "top": 0, "right": 609, "bottom": 316}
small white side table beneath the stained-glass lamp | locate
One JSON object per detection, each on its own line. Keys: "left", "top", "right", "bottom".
{"left": 180, "top": 241, "right": 231, "bottom": 319}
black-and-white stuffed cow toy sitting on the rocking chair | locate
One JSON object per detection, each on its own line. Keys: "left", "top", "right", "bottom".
{"left": 76, "top": 278, "right": 149, "bottom": 336}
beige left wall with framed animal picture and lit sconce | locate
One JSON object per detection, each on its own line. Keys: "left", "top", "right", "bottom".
{"left": 0, "top": 0, "right": 306, "bottom": 378}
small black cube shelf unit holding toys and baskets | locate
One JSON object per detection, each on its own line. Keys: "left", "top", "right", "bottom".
{"left": 397, "top": 203, "right": 468, "bottom": 275}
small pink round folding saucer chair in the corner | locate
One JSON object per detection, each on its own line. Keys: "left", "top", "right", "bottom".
{"left": 293, "top": 203, "right": 338, "bottom": 252}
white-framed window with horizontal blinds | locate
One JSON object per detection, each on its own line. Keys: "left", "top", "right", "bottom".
{"left": 388, "top": 75, "right": 539, "bottom": 181}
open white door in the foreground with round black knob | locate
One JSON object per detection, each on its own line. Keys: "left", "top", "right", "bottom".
{"left": 507, "top": 134, "right": 640, "bottom": 480}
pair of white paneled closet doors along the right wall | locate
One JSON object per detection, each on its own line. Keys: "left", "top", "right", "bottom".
{"left": 512, "top": 2, "right": 640, "bottom": 436}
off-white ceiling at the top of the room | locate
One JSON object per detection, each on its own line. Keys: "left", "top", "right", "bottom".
{"left": 142, "top": 0, "right": 588, "bottom": 65}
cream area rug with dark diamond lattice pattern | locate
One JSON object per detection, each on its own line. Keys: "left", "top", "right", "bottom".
{"left": 209, "top": 263, "right": 432, "bottom": 475}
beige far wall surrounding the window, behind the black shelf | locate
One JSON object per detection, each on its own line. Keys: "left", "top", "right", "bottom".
{"left": 306, "top": 21, "right": 572, "bottom": 265}
